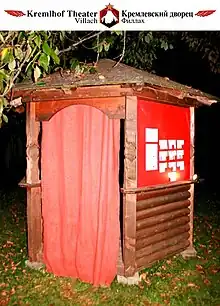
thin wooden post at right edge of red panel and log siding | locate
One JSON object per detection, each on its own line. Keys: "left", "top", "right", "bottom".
{"left": 182, "top": 107, "right": 196, "bottom": 258}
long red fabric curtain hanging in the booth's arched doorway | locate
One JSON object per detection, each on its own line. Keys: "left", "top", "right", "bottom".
{"left": 41, "top": 105, "right": 120, "bottom": 285}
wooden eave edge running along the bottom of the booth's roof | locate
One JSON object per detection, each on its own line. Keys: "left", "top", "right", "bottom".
{"left": 12, "top": 84, "right": 219, "bottom": 107}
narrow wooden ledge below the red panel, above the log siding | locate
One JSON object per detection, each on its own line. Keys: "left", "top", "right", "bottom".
{"left": 121, "top": 180, "right": 197, "bottom": 194}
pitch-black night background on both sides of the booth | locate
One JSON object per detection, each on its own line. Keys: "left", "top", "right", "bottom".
{"left": 0, "top": 38, "right": 220, "bottom": 194}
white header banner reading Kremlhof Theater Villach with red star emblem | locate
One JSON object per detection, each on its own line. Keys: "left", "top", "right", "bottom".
{"left": 0, "top": 0, "right": 220, "bottom": 31}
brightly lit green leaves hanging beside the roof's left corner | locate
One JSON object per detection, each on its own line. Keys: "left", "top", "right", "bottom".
{"left": 0, "top": 31, "right": 60, "bottom": 124}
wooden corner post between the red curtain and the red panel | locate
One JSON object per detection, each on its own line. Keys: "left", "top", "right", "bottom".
{"left": 123, "top": 96, "right": 137, "bottom": 277}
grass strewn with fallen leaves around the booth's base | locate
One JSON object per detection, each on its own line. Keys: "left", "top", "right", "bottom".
{"left": 0, "top": 190, "right": 220, "bottom": 306}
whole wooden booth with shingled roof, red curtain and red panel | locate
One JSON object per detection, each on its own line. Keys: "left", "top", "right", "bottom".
{"left": 12, "top": 59, "right": 216, "bottom": 285}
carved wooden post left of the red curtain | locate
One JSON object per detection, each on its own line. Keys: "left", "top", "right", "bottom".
{"left": 26, "top": 102, "right": 42, "bottom": 263}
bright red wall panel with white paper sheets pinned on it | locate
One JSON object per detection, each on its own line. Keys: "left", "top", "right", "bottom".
{"left": 137, "top": 99, "right": 190, "bottom": 187}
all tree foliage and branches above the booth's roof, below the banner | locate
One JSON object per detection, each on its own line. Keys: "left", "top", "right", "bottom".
{"left": 0, "top": 31, "right": 220, "bottom": 126}
